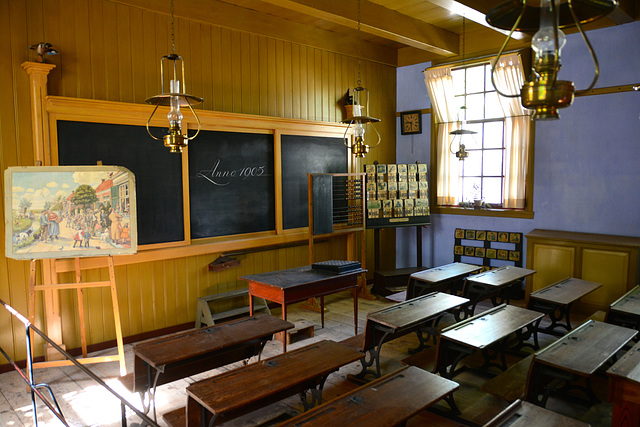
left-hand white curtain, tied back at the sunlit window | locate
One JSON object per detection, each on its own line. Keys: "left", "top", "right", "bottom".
{"left": 424, "top": 67, "right": 460, "bottom": 205}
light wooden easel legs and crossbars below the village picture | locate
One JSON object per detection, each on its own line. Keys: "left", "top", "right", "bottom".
{"left": 28, "top": 256, "right": 127, "bottom": 376}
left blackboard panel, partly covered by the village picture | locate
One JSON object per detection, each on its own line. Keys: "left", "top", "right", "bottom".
{"left": 57, "top": 120, "right": 185, "bottom": 245}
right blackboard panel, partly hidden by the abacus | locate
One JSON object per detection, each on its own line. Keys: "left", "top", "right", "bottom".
{"left": 282, "top": 135, "right": 348, "bottom": 229}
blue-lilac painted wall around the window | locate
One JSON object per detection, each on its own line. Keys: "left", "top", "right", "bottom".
{"left": 396, "top": 22, "right": 640, "bottom": 268}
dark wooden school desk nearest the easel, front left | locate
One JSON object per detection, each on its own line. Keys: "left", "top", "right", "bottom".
{"left": 132, "top": 314, "right": 294, "bottom": 413}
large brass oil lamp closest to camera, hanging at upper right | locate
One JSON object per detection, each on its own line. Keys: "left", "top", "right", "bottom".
{"left": 486, "top": 0, "right": 617, "bottom": 120}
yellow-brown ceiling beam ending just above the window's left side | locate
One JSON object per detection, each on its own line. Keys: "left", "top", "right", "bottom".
{"left": 252, "top": 0, "right": 460, "bottom": 55}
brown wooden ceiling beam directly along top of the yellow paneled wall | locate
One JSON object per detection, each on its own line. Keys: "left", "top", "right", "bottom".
{"left": 112, "top": 0, "right": 397, "bottom": 67}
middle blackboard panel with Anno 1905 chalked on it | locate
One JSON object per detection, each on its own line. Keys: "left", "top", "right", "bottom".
{"left": 189, "top": 131, "right": 275, "bottom": 239}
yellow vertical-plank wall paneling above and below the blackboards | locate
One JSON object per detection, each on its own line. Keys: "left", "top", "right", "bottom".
{"left": 0, "top": 0, "right": 395, "bottom": 364}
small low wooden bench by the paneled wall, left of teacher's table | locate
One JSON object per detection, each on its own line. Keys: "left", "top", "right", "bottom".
{"left": 196, "top": 288, "right": 271, "bottom": 328}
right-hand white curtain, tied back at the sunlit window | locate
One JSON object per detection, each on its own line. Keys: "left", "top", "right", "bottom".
{"left": 491, "top": 54, "right": 533, "bottom": 209}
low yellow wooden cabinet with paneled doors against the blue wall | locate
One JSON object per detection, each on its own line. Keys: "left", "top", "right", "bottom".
{"left": 525, "top": 229, "right": 640, "bottom": 313}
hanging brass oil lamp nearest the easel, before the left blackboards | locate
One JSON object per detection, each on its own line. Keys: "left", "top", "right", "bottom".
{"left": 145, "top": 0, "right": 202, "bottom": 153}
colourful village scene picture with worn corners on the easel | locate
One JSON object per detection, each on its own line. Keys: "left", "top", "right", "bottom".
{"left": 5, "top": 166, "right": 138, "bottom": 259}
